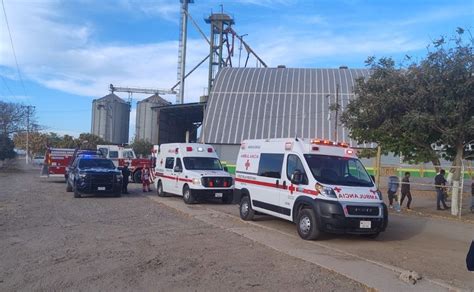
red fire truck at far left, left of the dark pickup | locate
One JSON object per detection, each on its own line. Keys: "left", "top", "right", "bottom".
{"left": 41, "top": 147, "right": 75, "bottom": 177}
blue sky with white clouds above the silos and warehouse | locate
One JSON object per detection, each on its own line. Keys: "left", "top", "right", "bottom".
{"left": 0, "top": 0, "right": 474, "bottom": 141}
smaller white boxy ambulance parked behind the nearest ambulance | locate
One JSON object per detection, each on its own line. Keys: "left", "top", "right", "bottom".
{"left": 152, "top": 143, "right": 234, "bottom": 204}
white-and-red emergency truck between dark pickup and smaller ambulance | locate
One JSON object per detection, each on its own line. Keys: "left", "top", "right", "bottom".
{"left": 97, "top": 145, "right": 151, "bottom": 183}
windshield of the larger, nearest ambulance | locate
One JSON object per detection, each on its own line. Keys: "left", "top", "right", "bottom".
{"left": 304, "top": 154, "right": 374, "bottom": 187}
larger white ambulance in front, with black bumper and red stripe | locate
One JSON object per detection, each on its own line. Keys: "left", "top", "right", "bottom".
{"left": 235, "top": 138, "right": 388, "bottom": 239}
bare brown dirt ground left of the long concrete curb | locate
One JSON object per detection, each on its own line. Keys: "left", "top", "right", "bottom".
{"left": 0, "top": 161, "right": 366, "bottom": 291}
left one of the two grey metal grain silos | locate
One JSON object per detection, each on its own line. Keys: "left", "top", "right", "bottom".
{"left": 91, "top": 93, "right": 130, "bottom": 144}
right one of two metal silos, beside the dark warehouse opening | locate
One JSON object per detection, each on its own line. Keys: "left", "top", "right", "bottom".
{"left": 135, "top": 94, "right": 171, "bottom": 144}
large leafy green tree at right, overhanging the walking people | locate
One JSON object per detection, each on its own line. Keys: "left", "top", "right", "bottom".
{"left": 341, "top": 28, "right": 474, "bottom": 214}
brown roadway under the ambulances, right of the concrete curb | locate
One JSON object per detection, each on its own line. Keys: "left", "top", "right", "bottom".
{"left": 197, "top": 198, "right": 474, "bottom": 290}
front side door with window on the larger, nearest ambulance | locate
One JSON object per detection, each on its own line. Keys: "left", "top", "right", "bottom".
{"left": 280, "top": 153, "right": 308, "bottom": 219}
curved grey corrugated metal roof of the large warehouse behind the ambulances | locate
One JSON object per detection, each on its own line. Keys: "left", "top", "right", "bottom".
{"left": 203, "top": 68, "right": 369, "bottom": 145}
